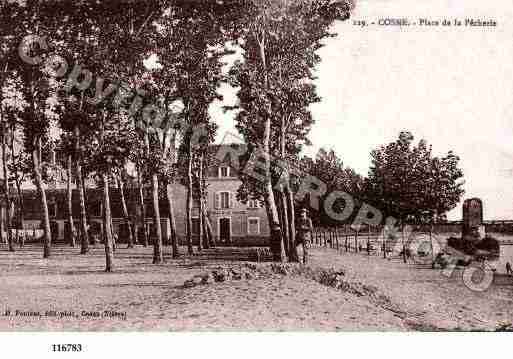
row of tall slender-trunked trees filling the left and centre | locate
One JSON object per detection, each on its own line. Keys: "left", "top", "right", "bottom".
{"left": 0, "top": 0, "right": 352, "bottom": 271}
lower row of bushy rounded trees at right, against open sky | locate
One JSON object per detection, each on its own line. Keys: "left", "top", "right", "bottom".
{"left": 301, "top": 131, "right": 464, "bottom": 226}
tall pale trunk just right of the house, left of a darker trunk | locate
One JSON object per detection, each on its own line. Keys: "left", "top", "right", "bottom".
{"left": 258, "top": 31, "right": 286, "bottom": 262}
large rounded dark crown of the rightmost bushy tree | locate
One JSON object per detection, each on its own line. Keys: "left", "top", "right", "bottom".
{"left": 365, "top": 132, "right": 464, "bottom": 222}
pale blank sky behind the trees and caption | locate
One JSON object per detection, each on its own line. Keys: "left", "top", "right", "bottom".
{"left": 212, "top": 0, "right": 513, "bottom": 219}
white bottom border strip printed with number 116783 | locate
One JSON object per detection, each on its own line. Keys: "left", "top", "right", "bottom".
{"left": 0, "top": 332, "right": 512, "bottom": 359}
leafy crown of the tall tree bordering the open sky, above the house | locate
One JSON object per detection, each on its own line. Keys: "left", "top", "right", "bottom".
{"left": 227, "top": 0, "right": 352, "bottom": 200}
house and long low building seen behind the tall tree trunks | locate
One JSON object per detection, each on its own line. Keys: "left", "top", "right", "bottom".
{"left": 4, "top": 156, "right": 269, "bottom": 246}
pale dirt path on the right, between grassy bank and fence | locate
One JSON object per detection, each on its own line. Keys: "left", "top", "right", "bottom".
{"left": 312, "top": 248, "right": 513, "bottom": 330}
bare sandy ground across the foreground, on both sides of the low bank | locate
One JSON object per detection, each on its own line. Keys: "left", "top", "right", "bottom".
{"left": 0, "top": 246, "right": 513, "bottom": 331}
